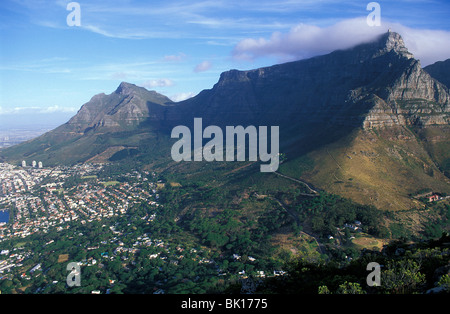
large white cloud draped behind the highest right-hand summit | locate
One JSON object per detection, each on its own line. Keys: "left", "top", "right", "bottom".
{"left": 233, "top": 18, "right": 450, "bottom": 65}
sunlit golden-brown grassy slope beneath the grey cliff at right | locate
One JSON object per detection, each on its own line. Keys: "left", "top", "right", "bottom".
{"left": 280, "top": 127, "right": 450, "bottom": 211}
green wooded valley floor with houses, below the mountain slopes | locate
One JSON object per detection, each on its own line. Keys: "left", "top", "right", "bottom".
{"left": 0, "top": 157, "right": 450, "bottom": 294}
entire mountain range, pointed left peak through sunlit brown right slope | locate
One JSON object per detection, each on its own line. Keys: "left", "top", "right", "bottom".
{"left": 0, "top": 32, "right": 450, "bottom": 208}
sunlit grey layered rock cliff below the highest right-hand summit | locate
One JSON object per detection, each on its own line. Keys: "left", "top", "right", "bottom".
{"left": 355, "top": 33, "right": 450, "bottom": 128}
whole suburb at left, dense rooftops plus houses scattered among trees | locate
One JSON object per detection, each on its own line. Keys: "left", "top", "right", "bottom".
{"left": 0, "top": 163, "right": 286, "bottom": 294}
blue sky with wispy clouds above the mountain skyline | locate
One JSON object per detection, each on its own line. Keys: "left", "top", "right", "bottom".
{"left": 0, "top": 0, "right": 450, "bottom": 124}
